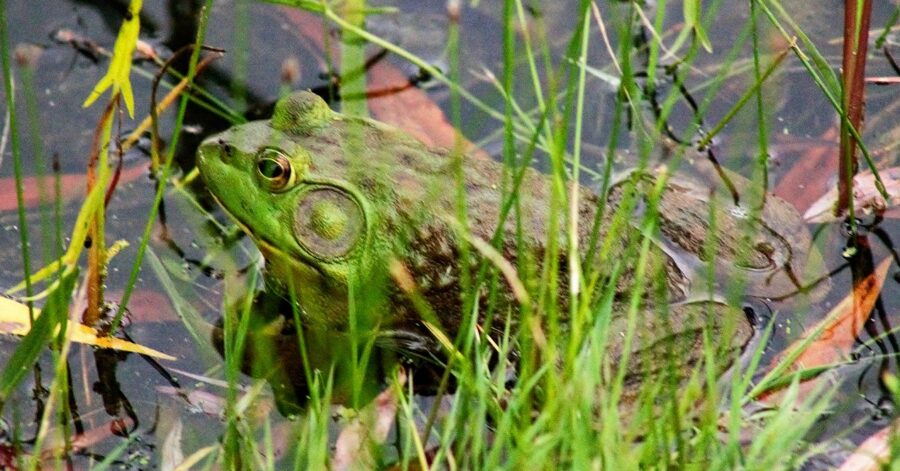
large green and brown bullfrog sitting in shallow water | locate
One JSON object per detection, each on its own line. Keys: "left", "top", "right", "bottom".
{"left": 197, "top": 91, "right": 810, "bottom": 400}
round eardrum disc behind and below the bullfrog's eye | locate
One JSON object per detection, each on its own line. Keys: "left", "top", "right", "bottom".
{"left": 294, "top": 186, "right": 365, "bottom": 261}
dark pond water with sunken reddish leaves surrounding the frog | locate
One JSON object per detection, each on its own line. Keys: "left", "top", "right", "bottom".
{"left": 0, "top": 0, "right": 900, "bottom": 469}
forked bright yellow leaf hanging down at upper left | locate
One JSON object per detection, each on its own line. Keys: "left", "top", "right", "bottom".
{"left": 82, "top": 0, "right": 143, "bottom": 118}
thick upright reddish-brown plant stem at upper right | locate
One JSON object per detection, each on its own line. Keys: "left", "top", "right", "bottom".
{"left": 835, "top": 0, "right": 872, "bottom": 215}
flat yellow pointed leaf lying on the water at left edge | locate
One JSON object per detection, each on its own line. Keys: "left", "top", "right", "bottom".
{"left": 0, "top": 297, "right": 176, "bottom": 360}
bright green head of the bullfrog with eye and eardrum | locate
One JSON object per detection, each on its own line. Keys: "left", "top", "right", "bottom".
{"left": 198, "top": 92, "right": 384, "bottom": 326}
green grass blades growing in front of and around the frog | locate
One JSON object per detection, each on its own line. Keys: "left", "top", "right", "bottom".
{"left": 0, "top": 0, "right": 896, "bottom": 469}
